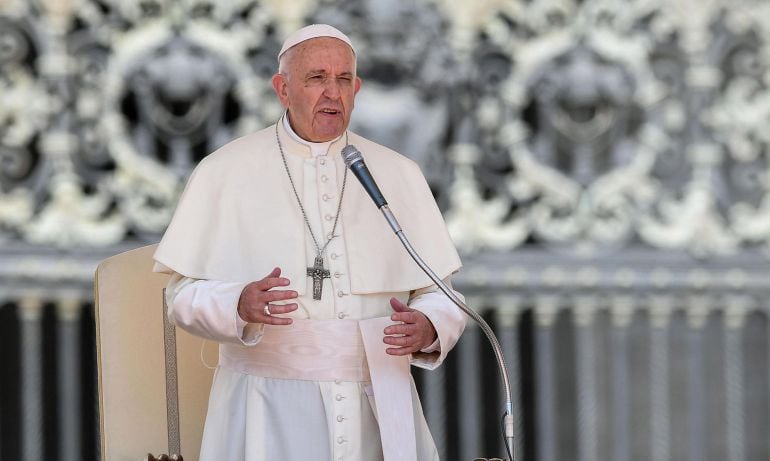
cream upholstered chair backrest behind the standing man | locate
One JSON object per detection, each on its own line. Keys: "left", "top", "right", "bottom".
{"left": 94, "top": 245, "right": 216, "bottom": 461}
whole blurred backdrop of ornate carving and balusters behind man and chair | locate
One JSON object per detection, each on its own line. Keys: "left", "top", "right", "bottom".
{"left": 0, "top": 0, "right": 770, "bottom": 461}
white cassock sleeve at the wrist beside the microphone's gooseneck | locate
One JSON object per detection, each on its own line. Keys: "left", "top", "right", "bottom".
{"left": 408, "top": 277, "right": 467, "bottom": 370}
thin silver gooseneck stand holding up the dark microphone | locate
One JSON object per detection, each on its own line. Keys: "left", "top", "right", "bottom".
{"left": 380, "top": 203, "right": 516, "bottom": 461}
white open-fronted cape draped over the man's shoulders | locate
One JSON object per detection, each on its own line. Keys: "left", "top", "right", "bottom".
{"left": 154, "top": 124, "right": 461, "bottom": 296}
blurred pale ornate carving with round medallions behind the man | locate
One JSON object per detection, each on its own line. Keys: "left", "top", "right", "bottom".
{"left": 0, "top": 0, "right": 770, "bottom": 256}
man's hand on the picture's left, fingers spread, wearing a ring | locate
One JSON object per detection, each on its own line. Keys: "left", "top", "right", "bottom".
{"left": 238, "top": 267, "right": 297, "bottom": 325}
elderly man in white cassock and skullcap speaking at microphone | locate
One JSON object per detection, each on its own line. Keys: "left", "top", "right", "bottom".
{"left": 155, "top": 25, "right": 465, "bottom": 461}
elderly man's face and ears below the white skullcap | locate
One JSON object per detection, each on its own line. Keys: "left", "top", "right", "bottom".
{"left": 272, "top": 37, "right": 361, "bottom": 142}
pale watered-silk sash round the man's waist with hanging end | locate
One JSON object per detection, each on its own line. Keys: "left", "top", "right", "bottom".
{"left": 219, "top": 317, "right": 417, "bottom": 461}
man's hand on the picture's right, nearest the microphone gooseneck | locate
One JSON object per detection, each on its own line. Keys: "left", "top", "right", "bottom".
{"left": 382, "top": 298, "right": 436, "bottom": 355}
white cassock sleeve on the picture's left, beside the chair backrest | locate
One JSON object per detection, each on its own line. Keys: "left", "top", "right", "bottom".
{"left": 166, "top": 273, "right": 264, "bottom": 346}
